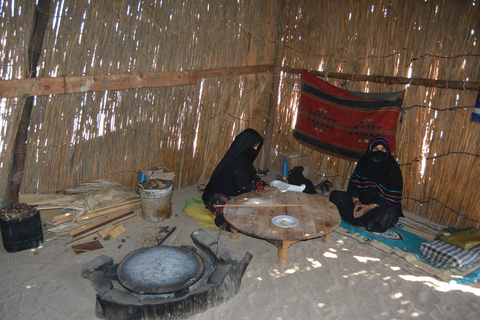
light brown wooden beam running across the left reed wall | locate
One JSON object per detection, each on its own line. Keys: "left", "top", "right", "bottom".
{"left": 0, "top": 65, "right": 273, "bottom": 98}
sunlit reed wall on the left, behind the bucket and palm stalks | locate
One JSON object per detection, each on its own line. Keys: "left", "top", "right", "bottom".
{"left": 3, "top": 0, "right": 278, "bottom": 198}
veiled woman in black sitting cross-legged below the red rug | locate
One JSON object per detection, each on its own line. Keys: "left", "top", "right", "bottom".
{"left": 330, "top": 136, "right": 403, "bottom": 232}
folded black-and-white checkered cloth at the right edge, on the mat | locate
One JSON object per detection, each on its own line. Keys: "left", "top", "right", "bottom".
{"left": 420, "top": 240, "right": 480, "bottom": 269}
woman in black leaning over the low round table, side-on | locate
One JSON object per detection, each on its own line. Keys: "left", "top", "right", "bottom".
{"left": 202, "top": 129, "right": 276, "bottom": 231}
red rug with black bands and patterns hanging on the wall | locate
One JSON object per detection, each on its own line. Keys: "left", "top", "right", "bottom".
{"left": 293, "top": 70, "right": 405, "bottom": 161}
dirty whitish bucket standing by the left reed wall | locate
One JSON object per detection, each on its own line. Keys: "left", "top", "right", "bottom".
{"left": 139, "top": 179, "right": 173, "bottom": 222}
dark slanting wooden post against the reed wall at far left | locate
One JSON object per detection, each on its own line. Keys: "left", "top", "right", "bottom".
{"left": 9, "top": 0, "right": 50, "bottom": 203}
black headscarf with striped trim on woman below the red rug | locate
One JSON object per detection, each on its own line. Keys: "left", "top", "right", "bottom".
{"left": 347, "top": 136, "right": 403, "bottom": 212}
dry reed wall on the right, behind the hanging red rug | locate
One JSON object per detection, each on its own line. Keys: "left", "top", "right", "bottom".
{"left": 279, "top": 0, "right": 480, "bottom": 228}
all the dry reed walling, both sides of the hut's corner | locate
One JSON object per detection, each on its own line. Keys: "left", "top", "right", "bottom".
{"left": 0, "top": 0, "right": 480, "bottom": 227}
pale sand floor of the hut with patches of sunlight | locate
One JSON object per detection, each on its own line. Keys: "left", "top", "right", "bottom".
{"left": 0, "top": 187, "right": 480, "bottom": 320}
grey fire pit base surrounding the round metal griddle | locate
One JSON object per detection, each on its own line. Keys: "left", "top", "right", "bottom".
{"left": 82, "top": 229, "right": 252, "bottom": 320}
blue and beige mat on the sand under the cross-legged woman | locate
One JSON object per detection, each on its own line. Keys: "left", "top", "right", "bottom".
{"left": 335, "top": 218, "right": 480, "bottom": 283}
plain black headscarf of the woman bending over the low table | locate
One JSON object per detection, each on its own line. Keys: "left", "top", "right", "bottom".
{"left": 202, "top": 129, "right": 263, "bottom": 201}
